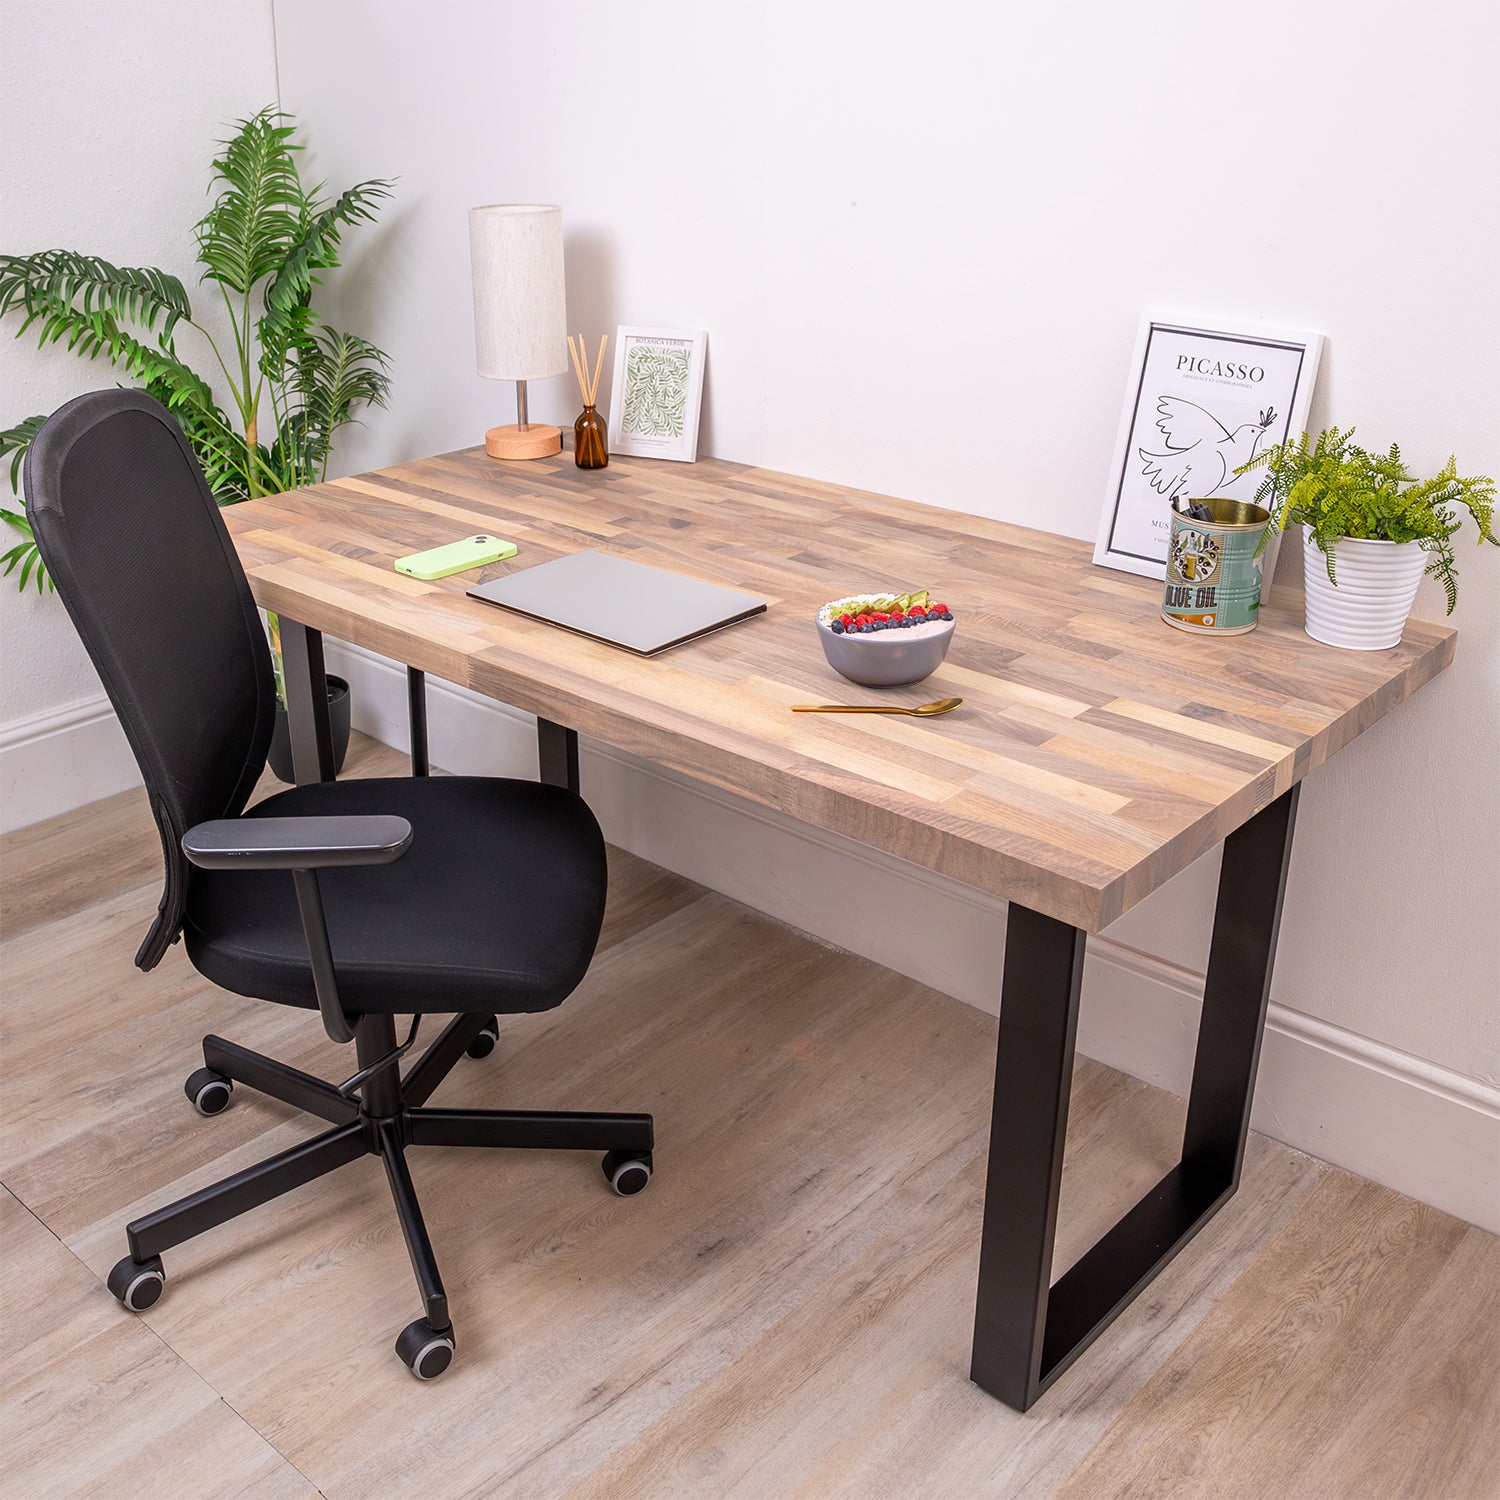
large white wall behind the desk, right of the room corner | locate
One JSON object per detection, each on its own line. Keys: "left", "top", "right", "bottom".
{"left": 276, "top": 0, "right": 1500, "bottom": 1221}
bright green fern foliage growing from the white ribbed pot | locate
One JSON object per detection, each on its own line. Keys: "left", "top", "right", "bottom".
{"left": 1235, "top": 428, "right": 1500, "bottom": 614}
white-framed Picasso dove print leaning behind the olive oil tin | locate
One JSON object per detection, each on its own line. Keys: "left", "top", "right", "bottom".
{"left": 1094, "top": 314, "right": 1323, "bottom": 579}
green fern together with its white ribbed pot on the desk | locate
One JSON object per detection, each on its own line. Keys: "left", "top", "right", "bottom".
{"left": 1236, "top": 428, "right": 1500, "bottom": 651}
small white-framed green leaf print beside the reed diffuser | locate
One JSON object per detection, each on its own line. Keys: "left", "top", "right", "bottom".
{"left": 609, "top": 327, "right": 708, "bottom": 464}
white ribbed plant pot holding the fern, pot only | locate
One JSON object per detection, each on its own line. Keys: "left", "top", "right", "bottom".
{"left": 1302, "top": 531, "right": 1427, "bottom": 651}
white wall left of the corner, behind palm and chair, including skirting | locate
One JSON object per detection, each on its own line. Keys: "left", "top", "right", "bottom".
{"left": 0, "top": 0, "right": 276, "bottom": 828}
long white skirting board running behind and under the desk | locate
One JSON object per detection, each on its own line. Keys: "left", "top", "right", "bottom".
{"left": 329, "top": 641, "right": 1500, "bottom": 1230}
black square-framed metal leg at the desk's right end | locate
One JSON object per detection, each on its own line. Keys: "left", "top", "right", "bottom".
{"left": 971, "top": 786, "right": 1299, "bottom": 1412}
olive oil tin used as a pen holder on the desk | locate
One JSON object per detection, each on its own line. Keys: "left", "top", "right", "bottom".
{"left": 1161, "top": 500, "right": 1271, "bottom": 636}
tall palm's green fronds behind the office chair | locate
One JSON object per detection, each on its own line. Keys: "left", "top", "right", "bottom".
{"left": 0, "top": 108, "right": 392, "bottom": 590}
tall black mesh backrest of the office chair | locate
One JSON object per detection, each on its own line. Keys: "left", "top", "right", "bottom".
{"left": 26, "top": 390, "right": 276, "bottom": 969}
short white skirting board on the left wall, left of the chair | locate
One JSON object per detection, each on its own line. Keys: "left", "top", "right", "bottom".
{"left": 0, "top": 693, "right": 141, "bottom": 833}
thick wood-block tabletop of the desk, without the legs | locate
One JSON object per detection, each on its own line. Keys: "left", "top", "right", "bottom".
{"left": 225, "top": 449, "right": 1455, "bottom": 932}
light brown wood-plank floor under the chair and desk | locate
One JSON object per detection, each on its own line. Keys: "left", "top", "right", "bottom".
{"left": 0, "top": 744, "right": 1500, "bottom": 1500}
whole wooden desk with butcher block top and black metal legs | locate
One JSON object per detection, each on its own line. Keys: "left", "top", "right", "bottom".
{"left": 225, "top": 449, "right": 1455, "bottom": 1410}
